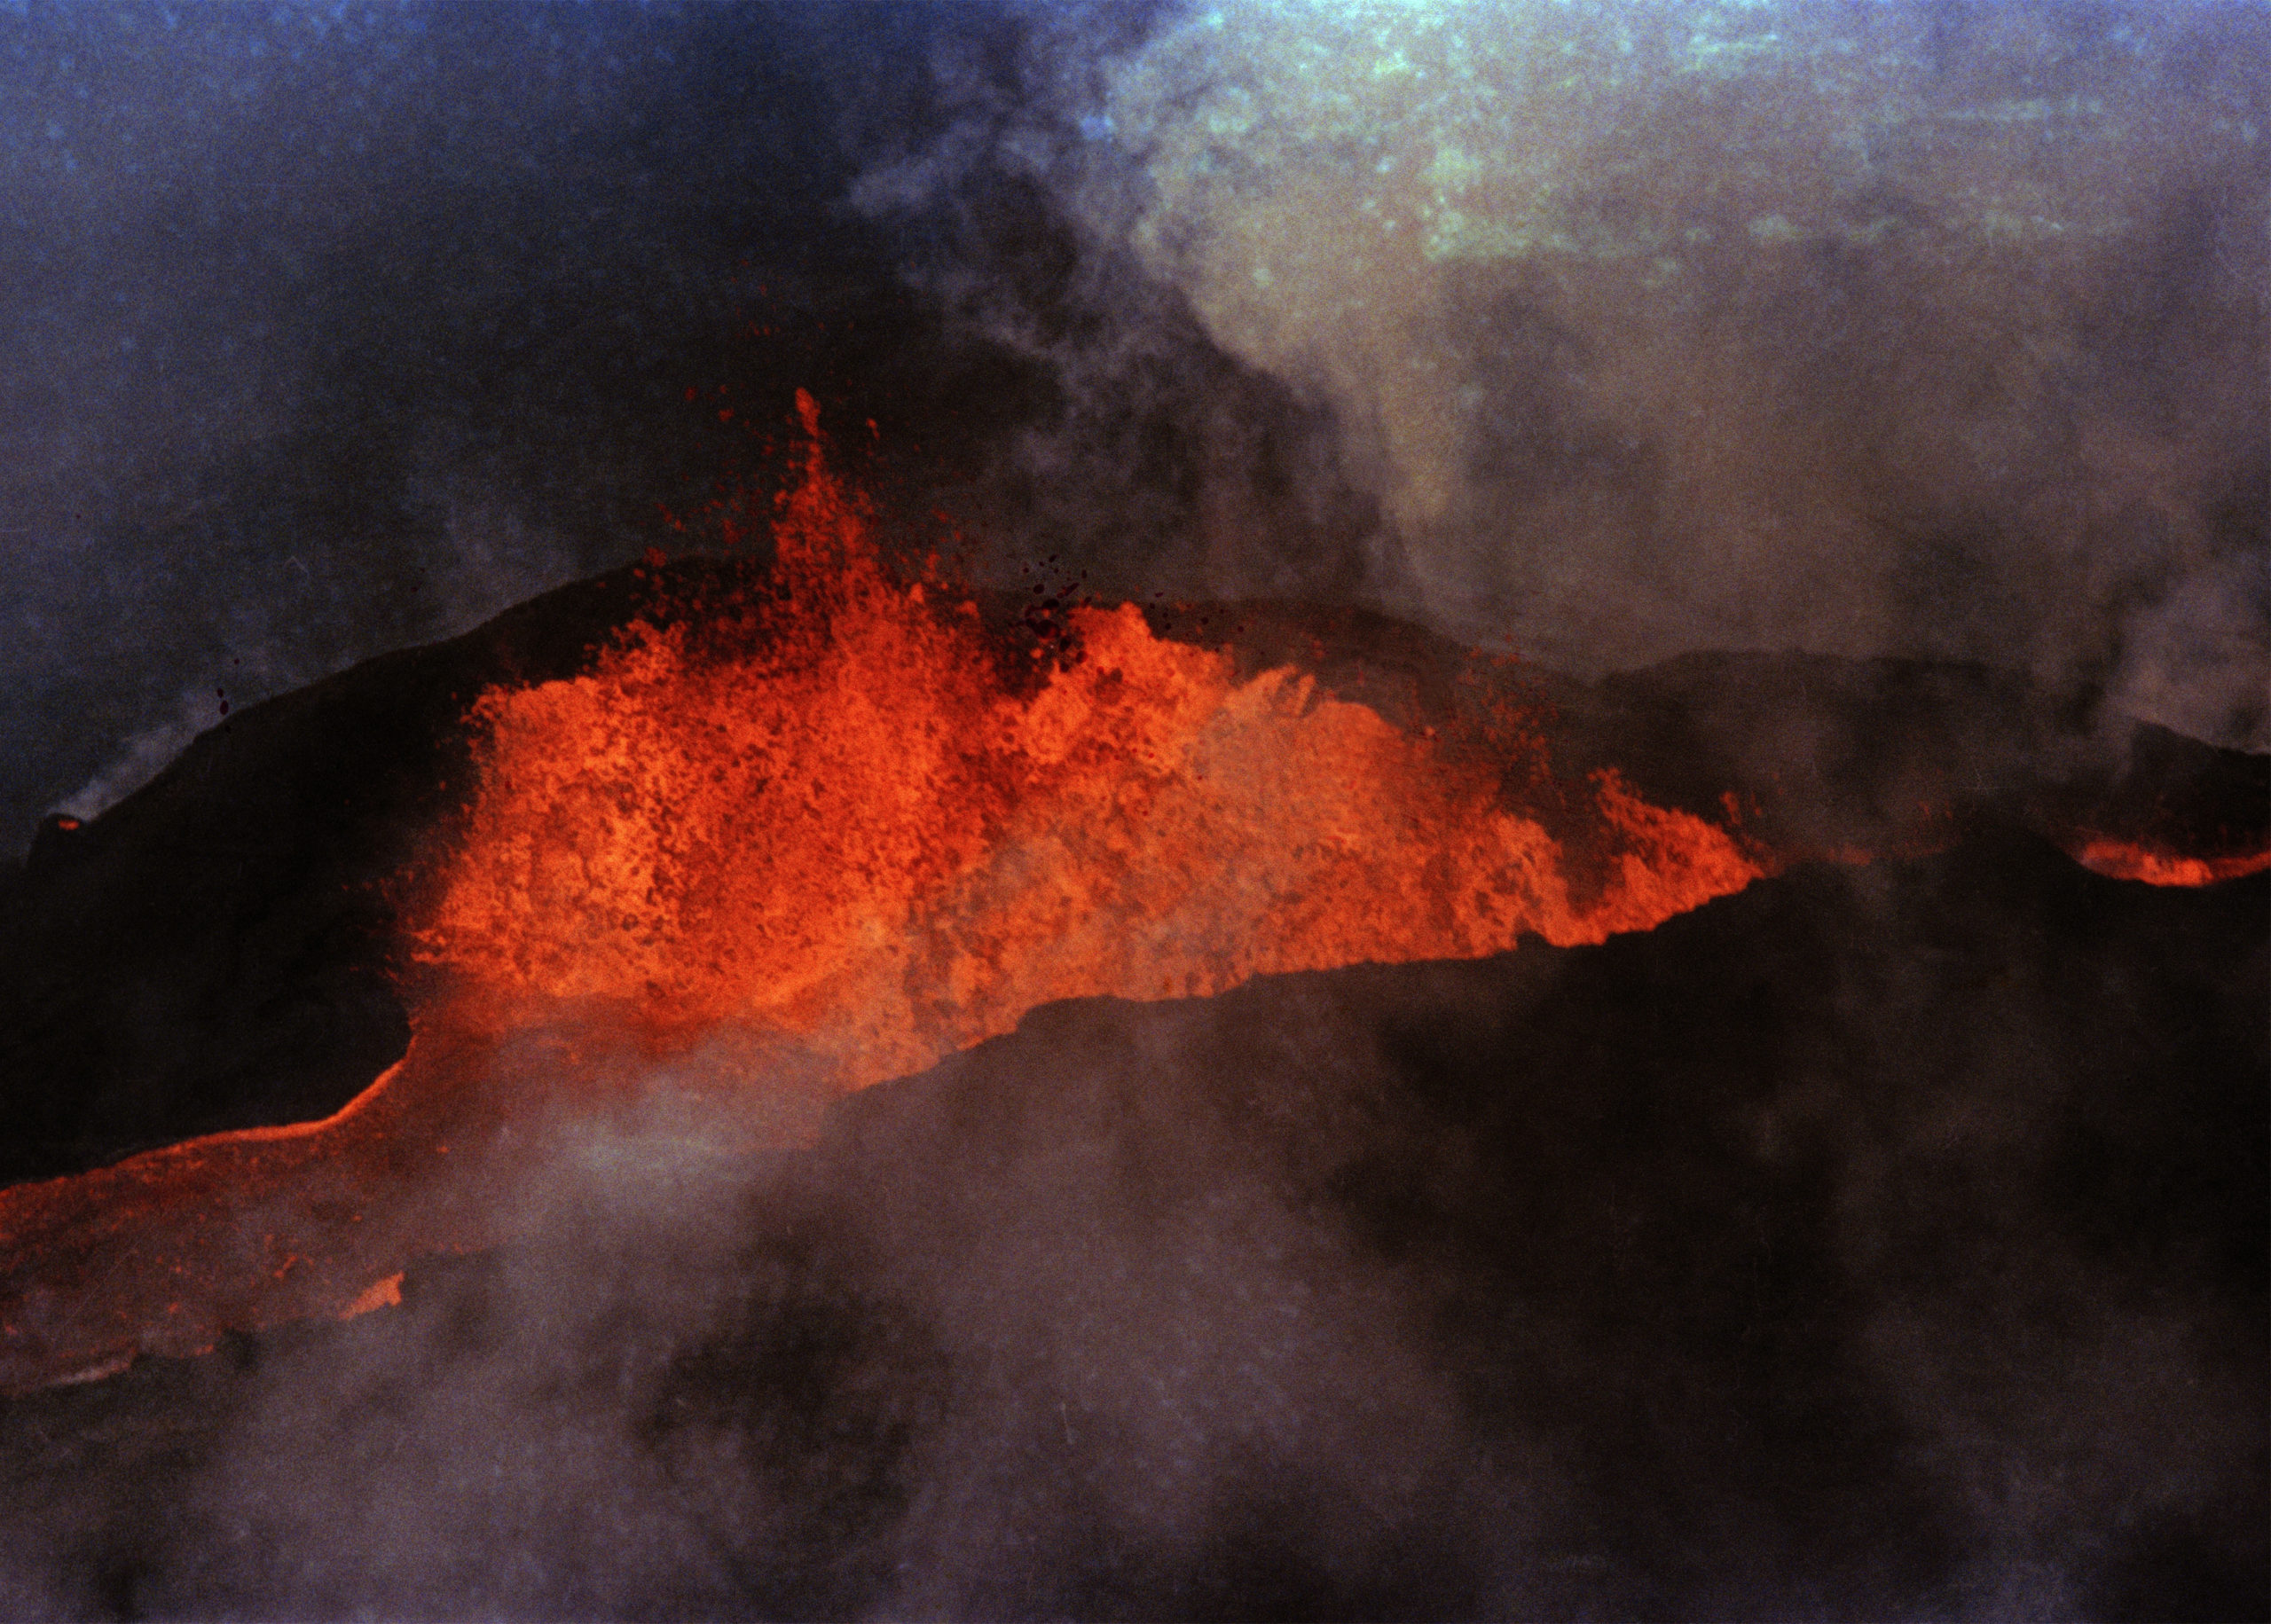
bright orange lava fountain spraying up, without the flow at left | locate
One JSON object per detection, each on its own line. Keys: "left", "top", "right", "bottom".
{"left": 415, "top": 400, "right": 1760, "bottom": 1086}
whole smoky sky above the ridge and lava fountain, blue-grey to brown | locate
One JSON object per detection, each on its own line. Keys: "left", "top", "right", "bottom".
{"left": 0, "top": 0, "right": 2271, "bottom": 850}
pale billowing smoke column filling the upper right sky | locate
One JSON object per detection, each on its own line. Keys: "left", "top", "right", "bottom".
{"left": 869, "top": 0, "right": 2271, "bottom": 749}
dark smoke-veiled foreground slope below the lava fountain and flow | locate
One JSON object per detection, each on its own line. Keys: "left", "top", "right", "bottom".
{"left": 0, "top": 818, "right": 2271, "bottom": 1620}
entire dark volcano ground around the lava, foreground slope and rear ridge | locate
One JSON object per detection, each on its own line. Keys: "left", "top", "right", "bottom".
{"left": 0, "top": 559, "right": 2271, "bottom": 1617}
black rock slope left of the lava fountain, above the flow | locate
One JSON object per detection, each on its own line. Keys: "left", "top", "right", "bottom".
{"left": 0, "top": 561, "right": 727, "bottom": 1183}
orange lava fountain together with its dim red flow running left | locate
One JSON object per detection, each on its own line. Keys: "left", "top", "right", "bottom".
{"left": 0, "top": 397, "right": 1764, "bottom": 1385}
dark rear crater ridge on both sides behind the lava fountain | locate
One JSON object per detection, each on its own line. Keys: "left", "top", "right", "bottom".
{"left": 0, "top": 543, "right": 2271, "bottom": 1186}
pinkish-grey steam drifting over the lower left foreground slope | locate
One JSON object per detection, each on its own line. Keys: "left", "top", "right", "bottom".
{"left": 0, "top": 1045, "right": 1530, "bottom": 1617}
